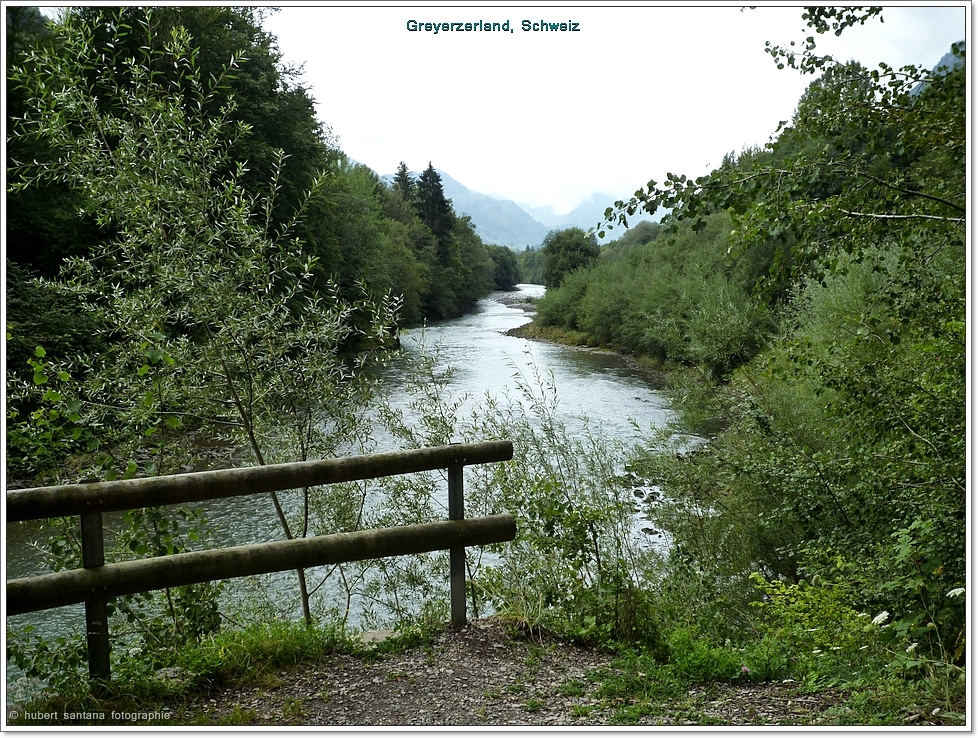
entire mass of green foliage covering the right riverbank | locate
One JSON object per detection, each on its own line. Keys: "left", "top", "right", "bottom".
{"left": 539, "top": 8, "right": 967, "bottom": 708}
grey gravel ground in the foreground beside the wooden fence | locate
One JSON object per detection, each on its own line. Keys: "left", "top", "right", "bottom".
{"left": 186, "top": 619, "right": 839, "bottom": 726}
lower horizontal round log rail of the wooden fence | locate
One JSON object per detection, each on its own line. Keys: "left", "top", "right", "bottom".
{"left": 7, "top": 515, "right": 516, "bottom": 615}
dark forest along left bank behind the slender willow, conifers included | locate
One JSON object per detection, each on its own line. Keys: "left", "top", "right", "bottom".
{"left": 6, "top": 7, "right": 518, "bottom": 408}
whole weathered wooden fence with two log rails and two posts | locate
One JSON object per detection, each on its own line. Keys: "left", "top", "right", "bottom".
{"left": 6, "top": 441, "right": 516, "bottom": 680}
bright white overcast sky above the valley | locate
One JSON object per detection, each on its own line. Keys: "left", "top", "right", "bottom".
{"left": 265, "top": 2, "right": 967, "bottom": 213}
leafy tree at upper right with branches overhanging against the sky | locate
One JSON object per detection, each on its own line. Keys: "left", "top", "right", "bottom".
{"left": 598, "top": 8, "right": 966, "bottom": 288}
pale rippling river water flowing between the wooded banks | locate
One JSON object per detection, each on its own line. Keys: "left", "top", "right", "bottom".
{"left": 6, "top": 285, "right": 669, "bottom": 688}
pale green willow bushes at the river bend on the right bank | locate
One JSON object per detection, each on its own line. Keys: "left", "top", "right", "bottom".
{"left": 538, "top": 213, "right": 771, "bottom": 373}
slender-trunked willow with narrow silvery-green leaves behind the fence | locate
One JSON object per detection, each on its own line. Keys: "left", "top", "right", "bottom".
{"left": 11, "top": 10, "right": 396, "bottom": 622}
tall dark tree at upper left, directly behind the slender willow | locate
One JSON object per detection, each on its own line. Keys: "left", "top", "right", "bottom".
{"left": 7, "top": 6, "right": 336, "bottom": 276}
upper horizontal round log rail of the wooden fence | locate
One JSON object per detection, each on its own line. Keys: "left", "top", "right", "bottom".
{"left": 7, "top": 441, "right": 513, "bottom": 522}
